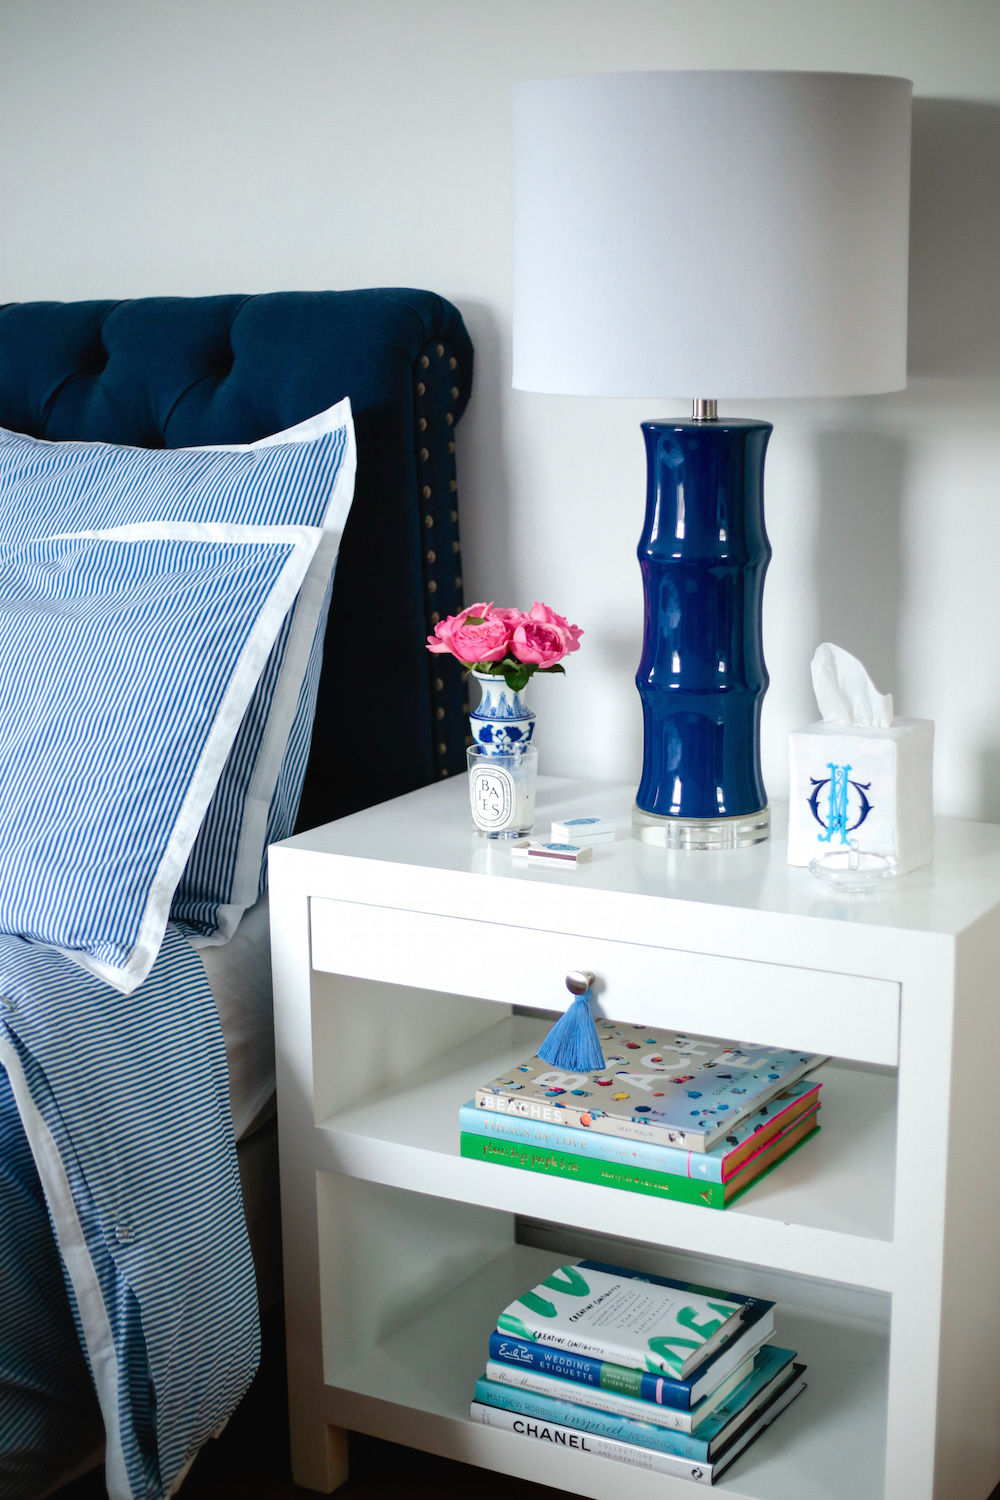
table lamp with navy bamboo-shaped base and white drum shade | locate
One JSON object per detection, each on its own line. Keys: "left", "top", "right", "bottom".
{"left": 513, "top": 72, "right": 912, "bottom": 849}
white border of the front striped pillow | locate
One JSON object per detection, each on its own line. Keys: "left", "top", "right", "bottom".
{"left": 39, "top": 521, "right": 324, "bottom": 995}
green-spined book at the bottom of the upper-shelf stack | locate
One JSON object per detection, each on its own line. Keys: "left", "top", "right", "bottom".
{"left": 459, "top": 1109, "right": 819, "bottom": 1209}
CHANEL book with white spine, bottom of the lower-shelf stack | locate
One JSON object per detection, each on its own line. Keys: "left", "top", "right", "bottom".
{"left": 469, "top": 1365, "right": 805, "bottom": 1485}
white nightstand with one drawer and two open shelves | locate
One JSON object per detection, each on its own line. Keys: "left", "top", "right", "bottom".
{"left": 270, "top": 779, "right": 1000, "bottom": 1500}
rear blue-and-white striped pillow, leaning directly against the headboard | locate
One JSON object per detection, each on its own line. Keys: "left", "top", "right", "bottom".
{"left": 0, "top": 401, "right": 357, "bottom": 942}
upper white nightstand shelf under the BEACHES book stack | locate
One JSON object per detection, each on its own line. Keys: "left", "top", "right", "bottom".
{"left": 319, "top": 1017, "right": 895, "bottom": 1290}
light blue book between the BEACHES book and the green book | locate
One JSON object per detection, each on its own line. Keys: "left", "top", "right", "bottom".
{"left": 459, "top": 1079, "right": 823, "bottom": 1184}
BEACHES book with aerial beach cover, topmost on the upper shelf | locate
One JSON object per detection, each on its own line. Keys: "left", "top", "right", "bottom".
{"left": 475, "top": 1020, "right": 826, "bottom": 1152}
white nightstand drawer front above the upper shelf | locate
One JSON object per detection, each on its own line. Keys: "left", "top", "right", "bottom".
{"left": 312, "top": 897, "right": 900, "bottom": 1065}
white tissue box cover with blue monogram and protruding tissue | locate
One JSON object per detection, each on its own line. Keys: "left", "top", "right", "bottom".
{"left": 789, "top": 642, "right": 934, "bottom": 875}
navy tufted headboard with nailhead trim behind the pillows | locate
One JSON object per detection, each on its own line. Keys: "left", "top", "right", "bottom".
{"left": 0, "top": 288, "right": 472, "bottom": 828}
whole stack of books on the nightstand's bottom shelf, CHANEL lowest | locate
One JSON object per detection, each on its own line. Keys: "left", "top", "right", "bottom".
{"left": 471, "top": 1260, "right": 805, "bottom": 1485}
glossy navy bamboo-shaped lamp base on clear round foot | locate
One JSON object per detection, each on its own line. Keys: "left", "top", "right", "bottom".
{"left": 633, "top": 402, "right": 772, "bottom": 849}
